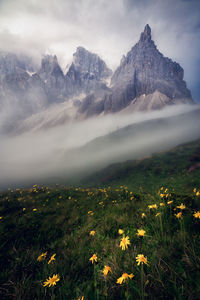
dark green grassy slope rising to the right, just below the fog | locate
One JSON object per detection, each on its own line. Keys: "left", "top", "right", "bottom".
{"left": 83, "top": 140, "right": 200, "bottom": 192}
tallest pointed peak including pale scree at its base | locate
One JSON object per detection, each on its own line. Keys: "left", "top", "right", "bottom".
{"left": 78, "top": 24, "right": 193, "bottom": 115}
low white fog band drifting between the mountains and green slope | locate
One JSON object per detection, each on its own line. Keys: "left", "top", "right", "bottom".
{"left": 0, "top": 105, "right": 200, "bottom": 188}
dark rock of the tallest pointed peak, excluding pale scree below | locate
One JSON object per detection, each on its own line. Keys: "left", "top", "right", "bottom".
{"left": 105, "top": 25, "right": 192, "bottom": 111}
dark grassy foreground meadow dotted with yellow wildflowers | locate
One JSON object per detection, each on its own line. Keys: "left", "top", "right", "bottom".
{"left": 0, "top": 185, "right": 200, "bottom": 300}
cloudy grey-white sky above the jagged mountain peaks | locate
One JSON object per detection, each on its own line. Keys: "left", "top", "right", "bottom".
{"left": 0, "top": 0, "right": 200, "bottom": 100}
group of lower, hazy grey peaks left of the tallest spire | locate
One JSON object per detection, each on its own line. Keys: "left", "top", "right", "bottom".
{"left": 0, "top": 47, "right": 112, "bottom": 129}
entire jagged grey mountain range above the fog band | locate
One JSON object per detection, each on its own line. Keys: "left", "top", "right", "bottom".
{"left": 0, "top": 24, "right": 193, "bottom": 133}
